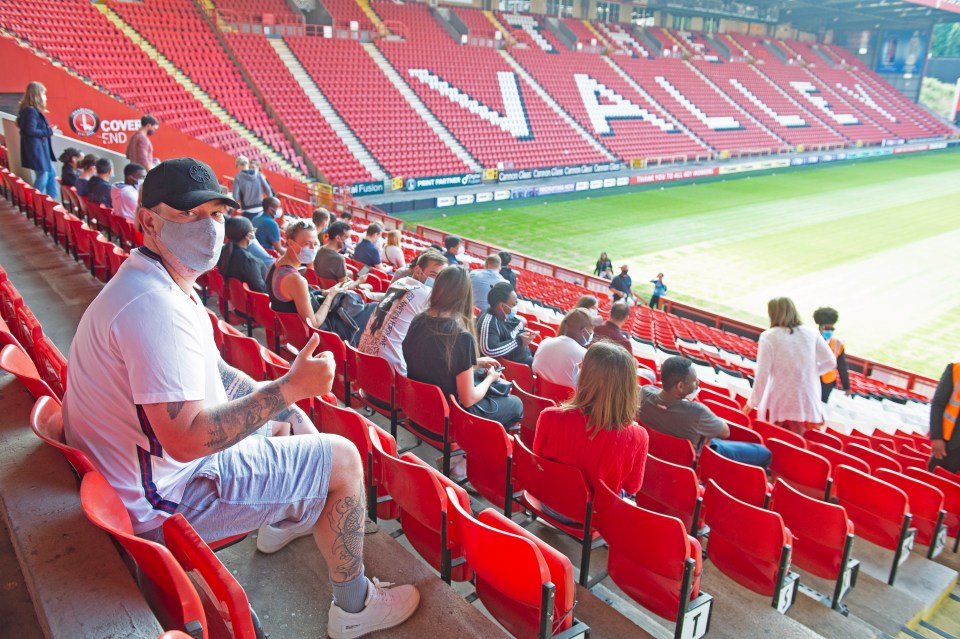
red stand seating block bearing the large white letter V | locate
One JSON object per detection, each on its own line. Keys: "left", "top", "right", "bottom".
{"left": 373, "top": 3, "right": 607, "bottom": 168}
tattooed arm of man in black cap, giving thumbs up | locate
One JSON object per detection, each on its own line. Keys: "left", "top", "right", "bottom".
{"left": 143, "top": 336, "right": 334, "bottom": 462}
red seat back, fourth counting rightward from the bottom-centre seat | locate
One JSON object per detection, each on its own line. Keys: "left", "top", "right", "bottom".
{"left": 770, "top": 480, "right": 854, "bottom": 580}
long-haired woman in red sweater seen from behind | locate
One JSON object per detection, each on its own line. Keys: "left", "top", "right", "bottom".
{"left": 533, "top": 341, "right": 649, "bottom": 495}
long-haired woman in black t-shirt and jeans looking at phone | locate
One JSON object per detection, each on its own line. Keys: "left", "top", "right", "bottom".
{"left": 403, "top": 266, "right": 523, "bottom": 428}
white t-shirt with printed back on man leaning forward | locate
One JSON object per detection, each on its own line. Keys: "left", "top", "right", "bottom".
{"left": 357, "top": 277, "right": 430, "bottom": 375}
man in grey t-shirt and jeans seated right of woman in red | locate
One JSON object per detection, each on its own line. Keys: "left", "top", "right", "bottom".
{"left": 637, "top": 357, "right": 771, "bottom": 468}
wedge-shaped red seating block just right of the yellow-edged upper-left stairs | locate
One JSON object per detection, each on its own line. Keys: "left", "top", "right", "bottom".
{"left": 110, "top": 0, "right": 306, "bottom": 171}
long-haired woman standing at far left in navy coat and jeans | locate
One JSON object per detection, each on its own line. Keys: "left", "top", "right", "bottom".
{"left": 17, "top": 82, "right": 60, "bottom": 200}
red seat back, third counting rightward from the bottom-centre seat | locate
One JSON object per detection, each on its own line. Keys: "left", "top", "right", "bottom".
{"left": 704, "top": 480, "right": 793, "bottom": 596}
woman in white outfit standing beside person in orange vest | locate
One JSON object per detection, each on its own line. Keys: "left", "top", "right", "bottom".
{"left": 745, "top": 297, "right": 837, "bottom": 435}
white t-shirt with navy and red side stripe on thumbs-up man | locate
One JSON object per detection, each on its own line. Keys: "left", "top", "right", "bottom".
{"left": 63, "top": 249, "right": 227, "bottom": 533}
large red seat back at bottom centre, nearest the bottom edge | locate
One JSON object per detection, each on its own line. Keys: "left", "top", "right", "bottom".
{"left": 447, "top": 489, "right": 575, "bottom": 637}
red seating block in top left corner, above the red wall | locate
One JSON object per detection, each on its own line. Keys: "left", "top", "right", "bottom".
{"left": 0, "top": 0, "right": 288, "bottom": 175}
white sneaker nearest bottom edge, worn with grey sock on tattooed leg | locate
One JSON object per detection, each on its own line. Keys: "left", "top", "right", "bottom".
{"left": 327, "top": 577, "right": 420, "bottom": 639}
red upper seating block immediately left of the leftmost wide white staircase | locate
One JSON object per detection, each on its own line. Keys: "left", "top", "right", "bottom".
{"left": 224, "top": 33, "right": 373, "bottom": 184}
